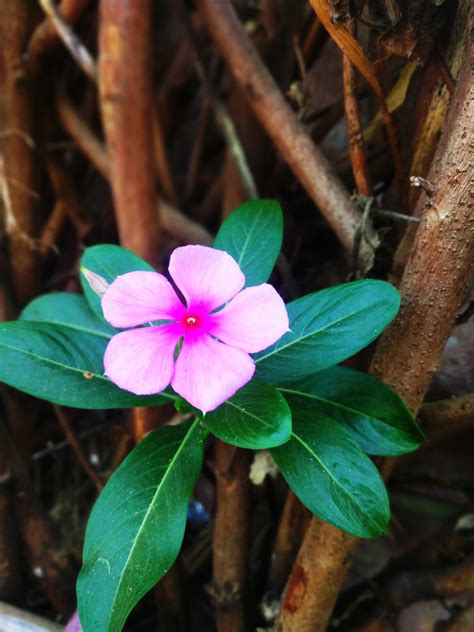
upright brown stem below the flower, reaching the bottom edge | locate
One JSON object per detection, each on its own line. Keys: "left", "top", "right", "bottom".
{"left": 209, "top": 440, "right": 250, "bottom": 632}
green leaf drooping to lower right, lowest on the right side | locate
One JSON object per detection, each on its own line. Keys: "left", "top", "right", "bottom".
{"left": 272, "top": 396, "right": 390, "bottom": 538}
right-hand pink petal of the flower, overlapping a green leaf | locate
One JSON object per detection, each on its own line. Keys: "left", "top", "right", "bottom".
{"left": 208, "top": 283, "right": 288, "bottom": 353}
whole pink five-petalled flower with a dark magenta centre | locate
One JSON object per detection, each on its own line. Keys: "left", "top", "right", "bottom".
{"left": 102, "top": 246, "right": 288, "bottom": 412}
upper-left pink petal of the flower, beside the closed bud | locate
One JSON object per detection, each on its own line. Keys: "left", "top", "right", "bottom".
{"left": 102, "top": 271, "right": 184, "bottom": 327}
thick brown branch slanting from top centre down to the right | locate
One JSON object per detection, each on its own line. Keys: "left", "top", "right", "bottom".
{"left": 197, "top": 0, "right": 359, "bottom": 260}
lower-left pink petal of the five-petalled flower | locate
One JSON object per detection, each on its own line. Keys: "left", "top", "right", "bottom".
{"left": 104, "top": 325, "right": 182, "bottom": 395}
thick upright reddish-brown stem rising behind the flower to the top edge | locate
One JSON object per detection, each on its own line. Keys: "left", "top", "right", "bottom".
{"left": 99, "top": 0, "right": 160, "bottom": 263}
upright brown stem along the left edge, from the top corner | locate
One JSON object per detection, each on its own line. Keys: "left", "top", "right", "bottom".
{"left": 0, "top": 0, "right": 39, "bottom": 304}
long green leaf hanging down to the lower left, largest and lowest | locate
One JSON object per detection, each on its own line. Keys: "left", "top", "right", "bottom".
{"left": 77, "top": 421, "right": 203, "bottom": 632}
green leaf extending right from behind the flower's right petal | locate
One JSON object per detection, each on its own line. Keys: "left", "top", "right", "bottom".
{"left": 255, "top": 280, "right": 400, "bottom": 384}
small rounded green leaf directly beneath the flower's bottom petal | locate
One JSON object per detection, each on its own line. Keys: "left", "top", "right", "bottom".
{"left": 204, "top": 381, "right": 291, "bottom": 450}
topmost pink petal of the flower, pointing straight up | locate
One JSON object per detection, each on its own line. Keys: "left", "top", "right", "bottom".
{"left": 169, "top": 246, "right": 245, "bottom": 311}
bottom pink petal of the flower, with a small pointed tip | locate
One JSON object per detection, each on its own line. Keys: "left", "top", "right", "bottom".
{"left": 171, "top": 336, "right": 255, "bottom": 413}
